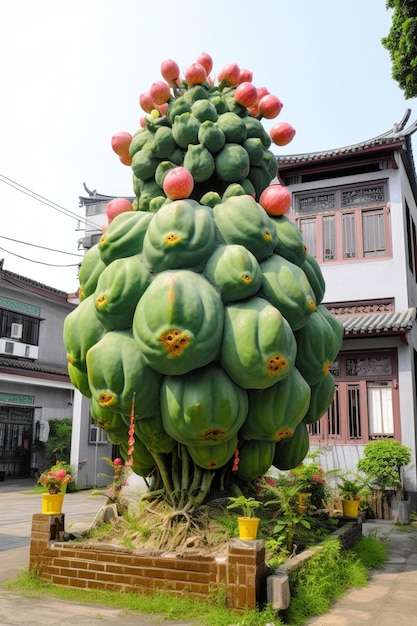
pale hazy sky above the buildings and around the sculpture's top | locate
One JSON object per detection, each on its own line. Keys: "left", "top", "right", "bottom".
{"left": 0, "top": 0, "right": 417, "bottom": 292}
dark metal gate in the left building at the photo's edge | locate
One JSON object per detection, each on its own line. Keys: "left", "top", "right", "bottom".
{"left": 0, "top": 405, "right": 34, "bottom": 478}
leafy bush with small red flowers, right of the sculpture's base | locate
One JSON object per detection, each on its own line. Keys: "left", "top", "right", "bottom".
{"left": 287, "top": 455, "right": 331, "bottom": 509}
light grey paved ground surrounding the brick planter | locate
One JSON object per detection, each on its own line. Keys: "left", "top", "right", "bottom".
{"left": 0, "top": 480, "right": 417, "bottom": 626}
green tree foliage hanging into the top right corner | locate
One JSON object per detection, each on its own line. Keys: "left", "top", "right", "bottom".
{"left": 381, "top": 0, "right": 417, "bottom": 99}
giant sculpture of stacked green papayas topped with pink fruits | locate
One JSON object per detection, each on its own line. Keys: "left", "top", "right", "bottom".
{"left": 64, "top": 53, "right": 343, "bottom": 514}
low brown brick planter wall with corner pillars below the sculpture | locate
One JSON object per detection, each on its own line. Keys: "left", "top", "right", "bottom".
{"left": 29, "top": 513, "right": 266, "bottom": 610}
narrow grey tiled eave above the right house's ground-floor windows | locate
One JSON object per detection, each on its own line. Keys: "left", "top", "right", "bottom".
{"left": 338, "top": 307, "right": 416, "bottom": 335}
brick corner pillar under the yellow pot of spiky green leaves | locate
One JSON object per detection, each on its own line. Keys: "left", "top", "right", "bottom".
{"left": 227, "top": 539, "right": 266, "bottom": 610}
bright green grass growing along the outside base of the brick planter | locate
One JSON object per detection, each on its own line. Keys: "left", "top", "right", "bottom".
{"left": 4, "top": 537, "right": 387, "bottom": 626}
